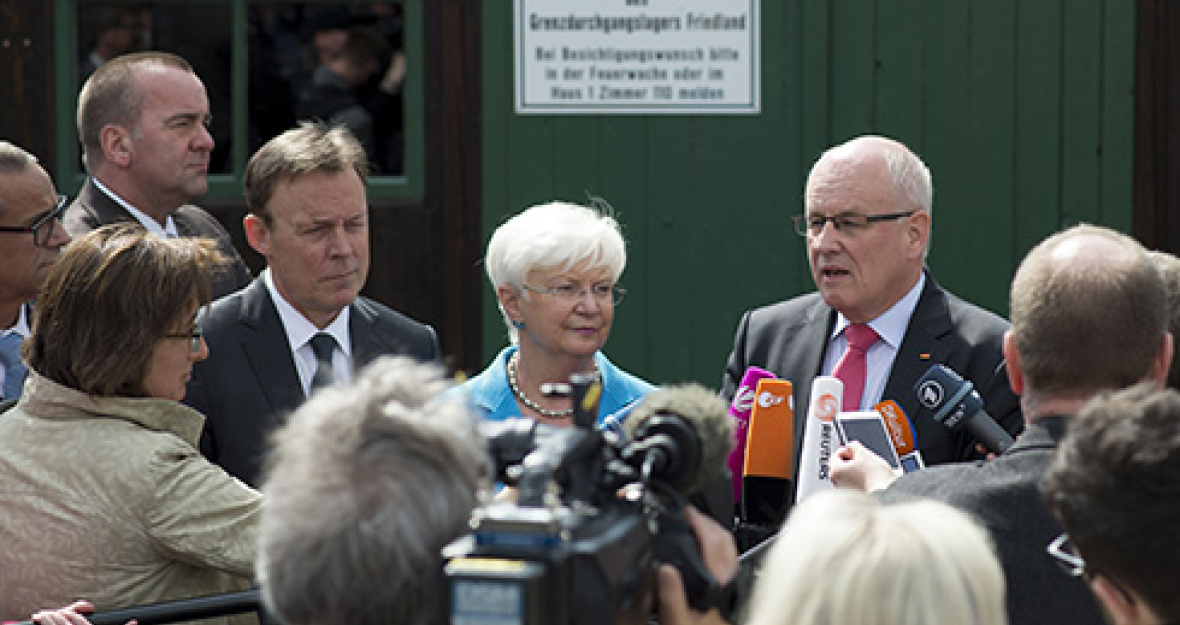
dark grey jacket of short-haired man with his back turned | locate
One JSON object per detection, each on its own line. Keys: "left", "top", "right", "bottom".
{"left": 879, "top": 416, "right": 1104, "bottom": 625}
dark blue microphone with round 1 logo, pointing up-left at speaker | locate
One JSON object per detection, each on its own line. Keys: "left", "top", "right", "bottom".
{"left": 913, "top": 364, "right": 1015, "bottom": 454}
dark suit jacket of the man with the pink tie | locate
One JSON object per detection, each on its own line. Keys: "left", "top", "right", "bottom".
{"left": 722, "top": 274, "right": 1023, "bottom": 476}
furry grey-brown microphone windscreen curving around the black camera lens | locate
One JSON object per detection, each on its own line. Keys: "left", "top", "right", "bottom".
{"left": 623, "top": 383, "right": 734, "bottom": 495}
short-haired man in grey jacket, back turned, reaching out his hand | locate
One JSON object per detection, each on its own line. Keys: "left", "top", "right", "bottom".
{"left": 832, "top": 225, "right": 1173, "bottom": 625}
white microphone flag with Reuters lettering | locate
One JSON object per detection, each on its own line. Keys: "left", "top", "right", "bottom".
{"left": 795, "top": 375, "right": 844, "bottom": 504}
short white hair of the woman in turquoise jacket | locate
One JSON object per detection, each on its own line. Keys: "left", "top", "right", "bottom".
{"left": 484, "top": 199, "right": 627, "bottom": 342}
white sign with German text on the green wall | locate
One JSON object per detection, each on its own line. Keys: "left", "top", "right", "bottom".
{"left": 513, "top": 0, "right": 760, "bottom": 114}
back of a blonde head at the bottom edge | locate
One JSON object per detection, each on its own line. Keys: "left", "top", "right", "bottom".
{"left": 747, "top": 489, "right": 1007, "bottom": 625}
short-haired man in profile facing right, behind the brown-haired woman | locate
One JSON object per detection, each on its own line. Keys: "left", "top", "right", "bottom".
{"left": 63, "top": 52, "right": 250, "bottom": 297}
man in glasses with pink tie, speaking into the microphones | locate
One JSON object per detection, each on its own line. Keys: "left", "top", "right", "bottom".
{"left": 722, "top": 132, "right": 1022, "bottom": 504}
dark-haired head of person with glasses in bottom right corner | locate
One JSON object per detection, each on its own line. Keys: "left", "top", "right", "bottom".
{"left": 1043, "top": 383, "right": 1180, "bottom": 623}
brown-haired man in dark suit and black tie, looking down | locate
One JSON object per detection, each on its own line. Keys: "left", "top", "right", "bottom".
{"left": 184, "top": 123, "right": 439, "bottom": 486}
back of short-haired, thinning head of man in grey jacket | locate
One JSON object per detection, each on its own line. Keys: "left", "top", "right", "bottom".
{"left": 1010, "top": 225, "right": 1169, "bottom": 399}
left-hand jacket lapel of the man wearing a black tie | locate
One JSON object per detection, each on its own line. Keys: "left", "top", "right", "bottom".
{"left": 241, "top": 278, "right": 306, "bottom": 422}
